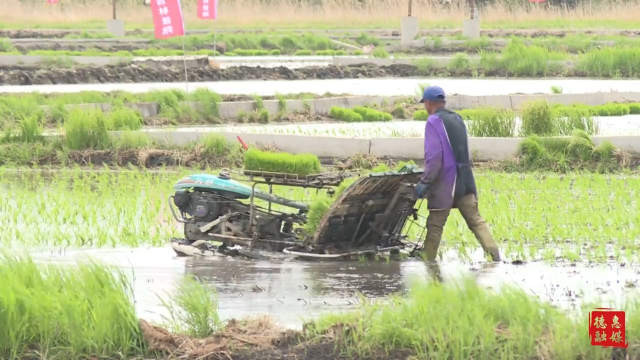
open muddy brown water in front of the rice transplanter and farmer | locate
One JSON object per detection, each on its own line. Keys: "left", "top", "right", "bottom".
{"left": 27, "top": 242, "right": 640, "bottom": 328}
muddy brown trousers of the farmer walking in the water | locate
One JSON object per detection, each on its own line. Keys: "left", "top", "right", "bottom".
{"left": 424, "top": 194, "right": 500, "bottom": 261}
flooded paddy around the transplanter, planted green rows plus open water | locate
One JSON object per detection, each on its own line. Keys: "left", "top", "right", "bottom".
{"left": 5, "top": 169, "right": 640, "bottom": 327}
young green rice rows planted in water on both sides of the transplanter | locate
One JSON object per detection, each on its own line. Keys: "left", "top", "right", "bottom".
{"left": 0, "top": 167, "right": 640, "bottom": 263}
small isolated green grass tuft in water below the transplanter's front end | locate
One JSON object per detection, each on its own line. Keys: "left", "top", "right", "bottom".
{"left": 158, "top": 276, "right": 223, "bottom": 338}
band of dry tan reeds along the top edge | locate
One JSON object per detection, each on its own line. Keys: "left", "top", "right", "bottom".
{"left": 0, "top": 0, "right": 640, "bottom": 30}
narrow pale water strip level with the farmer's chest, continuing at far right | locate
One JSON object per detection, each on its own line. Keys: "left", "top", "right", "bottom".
{"left": 143, "top": 115, "right": 640, "bottom": 138}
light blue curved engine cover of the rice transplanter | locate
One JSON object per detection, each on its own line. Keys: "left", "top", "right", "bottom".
{"left": 173, "top": 174, "right": 309, "bottom": 211}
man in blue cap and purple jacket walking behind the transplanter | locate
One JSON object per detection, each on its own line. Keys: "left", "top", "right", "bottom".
{"left": 415, "top": 86, "right": 500, "bottom": 261}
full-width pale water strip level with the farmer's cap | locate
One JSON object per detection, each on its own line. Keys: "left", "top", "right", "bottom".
{"left": 0, "top": 78, "right": 640, "bottom": 96}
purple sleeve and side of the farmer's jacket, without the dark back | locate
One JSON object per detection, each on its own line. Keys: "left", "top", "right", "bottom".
{"left": 421, "top": 114, "right": 457, "bottom": 209}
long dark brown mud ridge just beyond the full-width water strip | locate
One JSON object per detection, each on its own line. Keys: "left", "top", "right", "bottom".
{"left": 0, "top": 63, "right": 592, "bottom": 85}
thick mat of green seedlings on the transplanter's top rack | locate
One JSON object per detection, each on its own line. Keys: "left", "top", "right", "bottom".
{"left": 244, "top": 148, "right": 321, "bottom": 176}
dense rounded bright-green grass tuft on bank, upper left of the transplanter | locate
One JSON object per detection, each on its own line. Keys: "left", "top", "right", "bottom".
{"left": 64, "top": 108, "right": 109, "bottom": 150}
